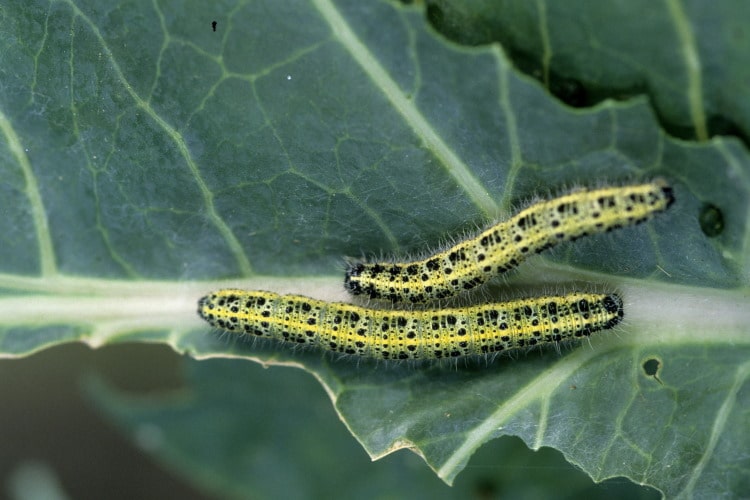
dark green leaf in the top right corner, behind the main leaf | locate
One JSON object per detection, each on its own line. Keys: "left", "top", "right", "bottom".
{"left": 426, "top": 0, "right": 750, "bottom": 140}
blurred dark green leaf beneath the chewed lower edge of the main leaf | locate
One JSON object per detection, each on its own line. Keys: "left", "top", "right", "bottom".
{"left": 86, "top": 359, "right": 656, "bottom": 499}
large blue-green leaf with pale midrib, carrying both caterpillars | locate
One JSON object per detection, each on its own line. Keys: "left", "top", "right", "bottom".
{"left": 0, "top": 0, "right": 750, "bottom": 496}
